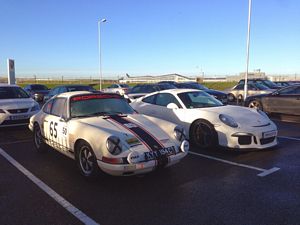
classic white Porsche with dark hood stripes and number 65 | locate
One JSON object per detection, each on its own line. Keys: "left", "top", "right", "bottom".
{"left": 29, "top": 92, "right": 189, "bottom": 177}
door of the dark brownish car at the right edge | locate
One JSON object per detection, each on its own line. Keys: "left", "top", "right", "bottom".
{"left": 262, "top": 86, "right": 300, "bottom": 115}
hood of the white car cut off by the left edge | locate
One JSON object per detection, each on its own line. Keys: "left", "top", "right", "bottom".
{"left": 0, "top": 98, "right": 37, "bottom": 109}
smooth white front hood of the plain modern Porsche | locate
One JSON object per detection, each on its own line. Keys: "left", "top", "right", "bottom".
{"left": 193, "top": 105, "right": 270, "bottom": 127}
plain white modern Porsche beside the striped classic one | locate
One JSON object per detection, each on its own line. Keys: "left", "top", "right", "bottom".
{"left": 131, "top": 89, "right": 277, "bottom": 149}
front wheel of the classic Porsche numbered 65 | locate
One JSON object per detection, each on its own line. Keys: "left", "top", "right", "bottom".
{"left": 76, "top": 141, "right": 100, "bottom": 179}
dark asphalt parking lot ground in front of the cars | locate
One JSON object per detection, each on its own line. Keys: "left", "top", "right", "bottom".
{"left": 0, "top": 120, "right": 300, "bottom": 225}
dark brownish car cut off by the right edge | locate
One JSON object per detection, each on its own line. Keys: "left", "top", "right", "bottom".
{"left": 245, "top": 85, "right": 300, "bottom": 116}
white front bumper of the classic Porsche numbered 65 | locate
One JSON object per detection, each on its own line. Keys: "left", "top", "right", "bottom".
{"left": 97, "top": 151, "right": 187, "bottom": 176}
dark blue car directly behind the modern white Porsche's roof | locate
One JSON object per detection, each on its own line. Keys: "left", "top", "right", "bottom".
{"left": 164, "top": 82, "right": 228, "bottom": 104}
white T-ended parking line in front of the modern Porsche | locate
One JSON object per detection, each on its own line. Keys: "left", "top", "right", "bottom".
{"left": 189, "top": 151, "right": 280, "bottom": 177}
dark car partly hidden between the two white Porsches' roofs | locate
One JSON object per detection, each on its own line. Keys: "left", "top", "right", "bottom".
{"left": 127, "top": 83, "right": 176, "bottom": 99}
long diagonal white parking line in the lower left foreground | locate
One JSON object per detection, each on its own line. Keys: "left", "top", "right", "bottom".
{"left": 0, "top": 148, "right": 99, "bottom": 225}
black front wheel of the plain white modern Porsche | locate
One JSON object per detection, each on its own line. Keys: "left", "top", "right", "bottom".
{"left": 190, "top": 119, "right": 218, "bottom": 149}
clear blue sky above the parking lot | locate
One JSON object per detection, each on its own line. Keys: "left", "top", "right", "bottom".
{"left": 0, "top": 0, "right": 300, "bottom": 77}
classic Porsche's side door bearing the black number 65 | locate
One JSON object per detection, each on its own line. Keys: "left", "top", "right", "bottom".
{"left": 44, "top": 98, "right": 69, "bottom": 154}
